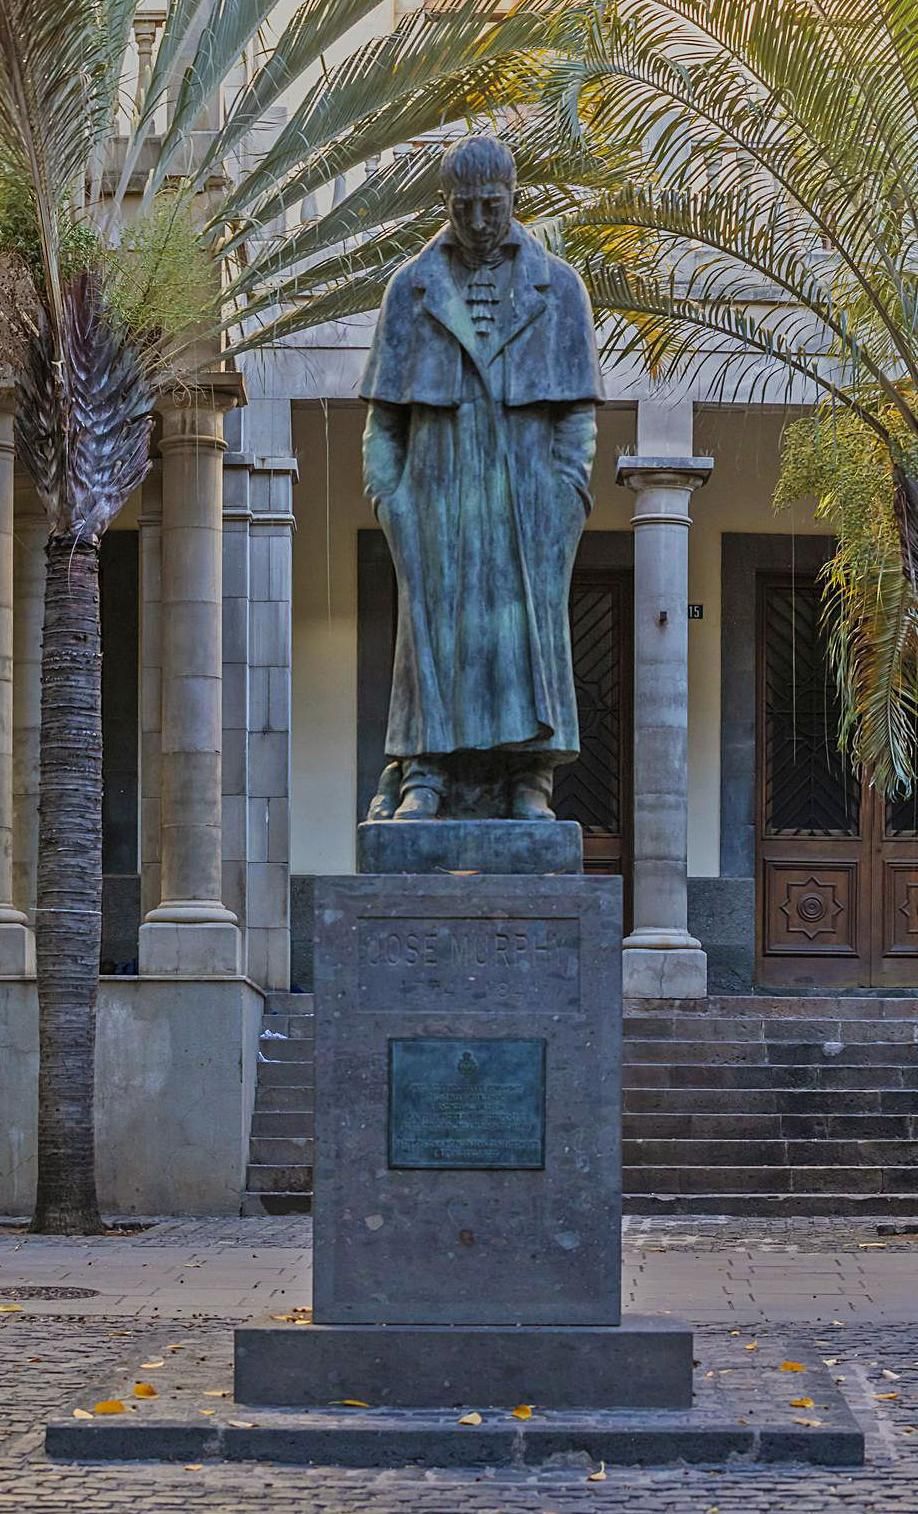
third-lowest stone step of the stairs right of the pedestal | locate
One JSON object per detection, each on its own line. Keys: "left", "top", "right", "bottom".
{"left": 623, "top": 1137, "right": 918, "bottom": 1170}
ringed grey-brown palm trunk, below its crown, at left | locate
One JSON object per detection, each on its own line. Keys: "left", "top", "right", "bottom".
{"left": 32, "top": 537, "right": 103, "bottom": 1234}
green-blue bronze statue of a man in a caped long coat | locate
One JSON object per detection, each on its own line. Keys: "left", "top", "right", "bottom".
{"left": 361, "top": 135, "right": 601, "bottom": 821}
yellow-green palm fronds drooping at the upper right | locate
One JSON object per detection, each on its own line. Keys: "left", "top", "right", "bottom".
{"left": 515, "top": 0, "right": 918, "bottom": 792}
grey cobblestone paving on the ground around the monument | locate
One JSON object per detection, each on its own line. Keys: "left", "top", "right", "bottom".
{"left": 0, "top": 1217, "right": 918, "bottom": 1514}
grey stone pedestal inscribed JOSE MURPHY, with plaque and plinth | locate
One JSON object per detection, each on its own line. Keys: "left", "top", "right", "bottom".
{"left": 236, "top": 872, "right": 692, "bottom": 1410}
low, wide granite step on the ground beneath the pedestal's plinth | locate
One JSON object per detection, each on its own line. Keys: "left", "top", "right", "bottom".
{"left": 45, "top": 1326, "right": 863, "bottom": 1482}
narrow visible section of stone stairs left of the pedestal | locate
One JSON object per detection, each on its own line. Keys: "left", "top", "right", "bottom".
{"left": 242, "top": 993, "right": 315, "bottom": 1214}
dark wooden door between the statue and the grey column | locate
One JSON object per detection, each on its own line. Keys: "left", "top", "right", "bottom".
{"left": 554, "top": 568, "right": 632, "bottom": 908}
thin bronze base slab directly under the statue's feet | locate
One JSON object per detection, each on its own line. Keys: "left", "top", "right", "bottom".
{"left": 358, "top": 821, "right": 583, "bottom": 874}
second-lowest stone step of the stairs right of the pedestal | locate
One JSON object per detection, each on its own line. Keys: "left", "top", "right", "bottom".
{"left": 624, "top": 1164, "right": 918, "bottom": 1193}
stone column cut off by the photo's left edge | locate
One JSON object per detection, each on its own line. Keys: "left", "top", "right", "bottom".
{"left": 0, "top": 389, "right": 35, "bottom": 978}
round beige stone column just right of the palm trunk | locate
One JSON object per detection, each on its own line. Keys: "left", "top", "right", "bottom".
{"left": 139, "top": 374, "right": 242, "bottom": 977}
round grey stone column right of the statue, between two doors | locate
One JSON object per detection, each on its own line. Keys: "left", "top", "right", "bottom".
{"left": 618, "top": 445, "right": 713, "bottom": 999}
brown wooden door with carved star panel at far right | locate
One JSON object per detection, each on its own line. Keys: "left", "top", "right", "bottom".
{"left": 757, "top": 578, "right": 918, "bottom": 990}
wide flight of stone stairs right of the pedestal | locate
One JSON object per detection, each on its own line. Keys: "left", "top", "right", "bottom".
{"left": 624, "top": 996, "right": 918, "bottom": 1214}
